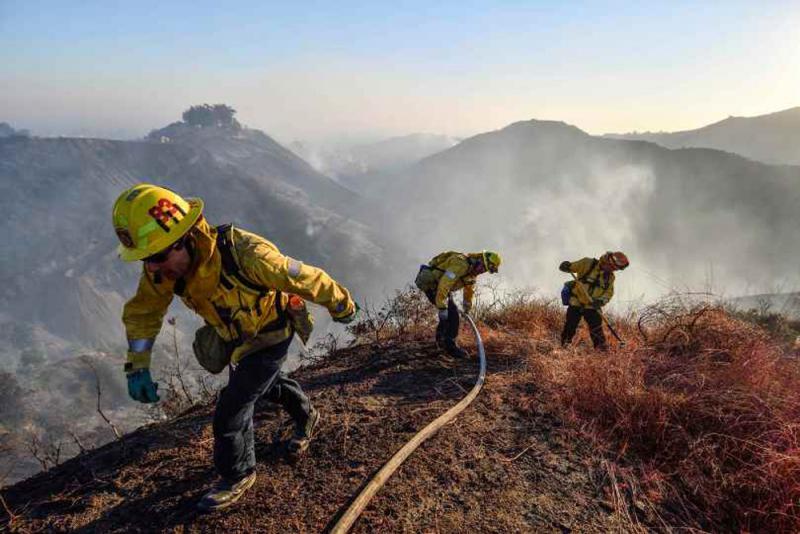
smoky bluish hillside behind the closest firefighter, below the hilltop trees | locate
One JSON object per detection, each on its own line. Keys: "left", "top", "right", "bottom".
{"left": 0, "top": 121, "right": 395, "bottom": 482}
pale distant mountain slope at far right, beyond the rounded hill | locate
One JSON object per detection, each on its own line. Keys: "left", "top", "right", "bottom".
{"left": 606, "top": 107, "right": 800, "bottom": 165}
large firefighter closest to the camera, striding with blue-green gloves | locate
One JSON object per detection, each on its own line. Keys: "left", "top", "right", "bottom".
{"left": 113, "top": 184, "right": 357, "bottom": 511}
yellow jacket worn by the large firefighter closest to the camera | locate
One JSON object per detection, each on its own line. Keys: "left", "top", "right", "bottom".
{"left": 122, "top": 219, "right": 355, "bottom": 370}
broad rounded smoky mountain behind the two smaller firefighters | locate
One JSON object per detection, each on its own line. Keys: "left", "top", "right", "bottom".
{"left": 374, "top": 120, "right": 800, "bottom": 305}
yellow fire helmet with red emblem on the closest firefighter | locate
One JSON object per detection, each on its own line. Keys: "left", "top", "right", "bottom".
{"left": 112, "top": 184, "right": 203, "bottom": 261}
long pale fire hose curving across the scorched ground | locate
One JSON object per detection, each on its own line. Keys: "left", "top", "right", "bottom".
{"left": 330, "top": 313, "right": 486, "bottom": 534}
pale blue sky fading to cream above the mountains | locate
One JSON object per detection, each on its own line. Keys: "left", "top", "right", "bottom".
{"left": 0, "top": 0, "right": 800, "bottom": 141}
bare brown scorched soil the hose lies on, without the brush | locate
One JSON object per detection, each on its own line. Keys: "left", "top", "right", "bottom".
{"left": 2, "top": 342, "right": 616, "bottom": 533}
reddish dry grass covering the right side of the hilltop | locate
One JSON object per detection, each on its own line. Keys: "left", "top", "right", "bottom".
{"left": 487, "top": 303, "right": 800, "bottom": 532}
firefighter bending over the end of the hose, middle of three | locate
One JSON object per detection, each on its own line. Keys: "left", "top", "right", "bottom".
{"left": 414, "top": 250, "right": 500, "bottom": 358}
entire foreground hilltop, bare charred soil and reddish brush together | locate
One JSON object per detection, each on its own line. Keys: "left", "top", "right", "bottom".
{"left": 2, "top": 295, "right": 800, "bottom": 532}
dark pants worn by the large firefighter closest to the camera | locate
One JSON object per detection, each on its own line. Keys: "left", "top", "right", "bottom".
{"left": 213, "top": 337, "right": 311, "bottom": 482}
